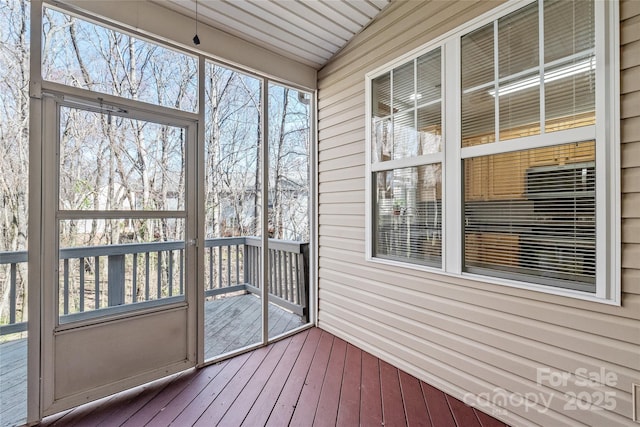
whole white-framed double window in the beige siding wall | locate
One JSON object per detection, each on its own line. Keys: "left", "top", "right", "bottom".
{"left": 368, "top": 0, "right": 619, "bottom": 302}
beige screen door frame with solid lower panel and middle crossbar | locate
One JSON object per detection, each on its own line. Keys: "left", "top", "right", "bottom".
{"left": 34, "top": 93, "right": 201, "bottom": 416}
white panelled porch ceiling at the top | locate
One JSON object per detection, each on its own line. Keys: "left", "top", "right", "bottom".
{"left": 151, "top": 0, "right": 391, "bottom": 69}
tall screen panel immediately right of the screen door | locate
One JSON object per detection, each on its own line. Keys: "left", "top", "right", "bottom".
{"left": 203, "top": 61, "right": 264, "bottom": 360}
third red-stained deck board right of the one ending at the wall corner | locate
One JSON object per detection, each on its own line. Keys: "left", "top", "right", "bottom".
{"left": 336, "top": 344, "right": 362, "bottom": 427}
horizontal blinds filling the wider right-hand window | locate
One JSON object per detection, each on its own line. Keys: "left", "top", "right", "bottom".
{"left": 461, "top": 0, "right": 596, "bottom": 292}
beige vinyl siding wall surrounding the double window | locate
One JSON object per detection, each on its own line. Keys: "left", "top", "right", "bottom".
{"left": 318, "top": 0, "right": 640, "bottom": 426}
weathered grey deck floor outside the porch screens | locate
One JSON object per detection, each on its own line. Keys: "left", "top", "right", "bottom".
{"left": 0, "top": 294, "right": 303, "bottom": 427}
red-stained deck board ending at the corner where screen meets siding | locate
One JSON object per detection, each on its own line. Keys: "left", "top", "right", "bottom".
{"left": 266, "top": 328, "right": 322, "bottom": 427}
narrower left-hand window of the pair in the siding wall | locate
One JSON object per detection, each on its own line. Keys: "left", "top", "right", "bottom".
{"left": 371, "top": 48, "right": 443, "bottom": 267}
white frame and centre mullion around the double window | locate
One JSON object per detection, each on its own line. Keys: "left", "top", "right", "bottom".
{"left": 365, "top": 0, "right": 621, "bottom": 305}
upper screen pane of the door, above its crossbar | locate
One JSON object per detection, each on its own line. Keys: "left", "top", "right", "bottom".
{"left": 59, "top": 107, "right": 186, "bottom": 210}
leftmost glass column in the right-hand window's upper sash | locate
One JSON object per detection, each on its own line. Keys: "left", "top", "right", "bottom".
{"left": 461, "top": 24, "right": 495, "bottom": 147}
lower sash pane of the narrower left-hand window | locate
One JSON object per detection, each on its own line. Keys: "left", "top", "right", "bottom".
{"left": 373, "top": 164, "right": 442, "bottom": 267}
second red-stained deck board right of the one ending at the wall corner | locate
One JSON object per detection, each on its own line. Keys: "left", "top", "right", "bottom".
{"left": 313, "top": 338, "right": 347, "bottom": 427}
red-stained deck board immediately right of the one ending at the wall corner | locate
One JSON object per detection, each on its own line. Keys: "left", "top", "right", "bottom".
{"left": 290, "top": 332, "right": 334, "bottom": 427}
